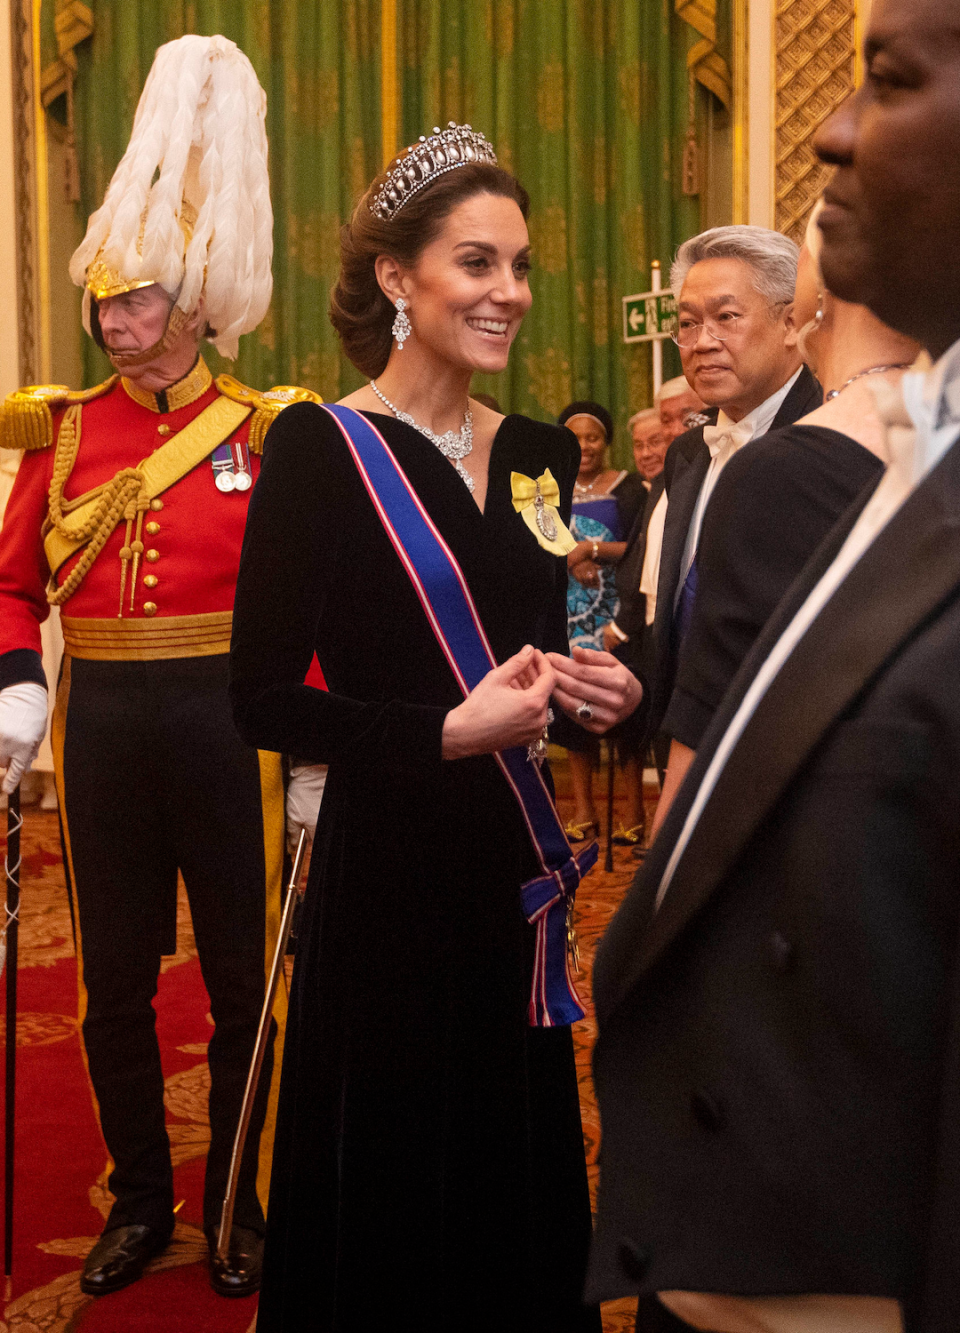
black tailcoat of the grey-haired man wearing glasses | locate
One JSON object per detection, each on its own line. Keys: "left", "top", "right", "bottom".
{"left": 645, "top": 365, "right": 823, "bottom": 736}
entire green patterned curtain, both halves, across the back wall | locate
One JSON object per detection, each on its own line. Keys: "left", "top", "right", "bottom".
{"left": 58, "top": 0, "right": 700, "bottom": 461}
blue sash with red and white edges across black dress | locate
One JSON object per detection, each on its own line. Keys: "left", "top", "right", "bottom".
{"left": 324, "top": 404, "right": 597, "bottom": 1028}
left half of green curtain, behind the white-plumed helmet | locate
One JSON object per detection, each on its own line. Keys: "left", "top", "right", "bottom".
{"left": 69, "top": 0, "right": 381, "bottom": 399}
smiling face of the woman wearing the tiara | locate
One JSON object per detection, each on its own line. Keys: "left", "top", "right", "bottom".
{"left": 403, "top": 193, "right": 532, "bottom": 375}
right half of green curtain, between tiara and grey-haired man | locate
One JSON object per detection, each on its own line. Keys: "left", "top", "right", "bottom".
{"left": 399, "top": 0, "right": 699, "bottom": 463}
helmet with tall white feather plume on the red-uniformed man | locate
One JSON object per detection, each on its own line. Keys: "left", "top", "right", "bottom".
{"left": 69, "top": 35, "right": 273, "bottom": 359}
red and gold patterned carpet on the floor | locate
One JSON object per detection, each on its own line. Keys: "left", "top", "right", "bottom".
{"left": 0, "top": 768, "right": 652, "bottom": 1333}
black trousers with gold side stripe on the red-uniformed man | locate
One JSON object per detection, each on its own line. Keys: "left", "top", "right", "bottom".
{"left": 53, "top": 655, "right": 283, "bottom": 1232}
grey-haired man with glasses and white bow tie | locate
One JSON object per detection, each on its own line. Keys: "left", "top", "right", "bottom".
{"left": 647, "top": 227, "right": 821, "bottom": 815}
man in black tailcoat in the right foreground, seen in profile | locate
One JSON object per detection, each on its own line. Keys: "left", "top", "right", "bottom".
{"left": 588, "top": 0, "right": 960, "bottom": 1333}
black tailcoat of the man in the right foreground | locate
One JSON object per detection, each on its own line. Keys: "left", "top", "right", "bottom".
{"left": 588, "top": 429, "right": 960, "bottom": 1333}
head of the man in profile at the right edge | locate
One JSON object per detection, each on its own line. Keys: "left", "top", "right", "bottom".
{"left": 817, "top": 0, "right": 960, "bottom": 356}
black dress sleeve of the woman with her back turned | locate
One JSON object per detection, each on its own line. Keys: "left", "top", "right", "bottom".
{"left": 663, "top": 428, "right": 879, "bottom": 749}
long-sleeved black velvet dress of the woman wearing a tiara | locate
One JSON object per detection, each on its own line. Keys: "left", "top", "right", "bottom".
{"left": 232, "top": 404, "right": 600, "bottom": 1333}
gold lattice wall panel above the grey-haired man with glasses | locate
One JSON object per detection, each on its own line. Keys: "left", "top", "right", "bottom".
{"left": 775, "top": 0, "right": 856, "bottom": 241}
